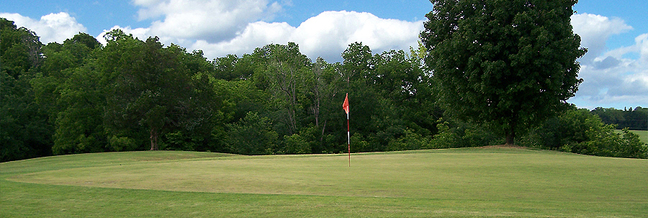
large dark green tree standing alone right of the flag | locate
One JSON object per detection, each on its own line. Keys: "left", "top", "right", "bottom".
{"left": 420, "top": 0, "right": 586, "bottom": 144}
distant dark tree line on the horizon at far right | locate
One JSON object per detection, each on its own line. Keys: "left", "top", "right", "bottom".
{"left": 592, "top": 107, "right": 648, "bottom": 130}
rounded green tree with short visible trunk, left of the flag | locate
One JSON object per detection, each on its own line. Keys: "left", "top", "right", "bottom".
{"left": 99, "top": 30, "right": 215, "bottom": 150}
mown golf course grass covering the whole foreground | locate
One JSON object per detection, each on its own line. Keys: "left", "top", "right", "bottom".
{"left": 0, "top": 148, "right": 648, "bottom": 217}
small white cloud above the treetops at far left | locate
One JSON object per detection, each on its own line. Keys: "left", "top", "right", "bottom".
{"left": 0, "top": 12, "right": 87, "bottom": 43}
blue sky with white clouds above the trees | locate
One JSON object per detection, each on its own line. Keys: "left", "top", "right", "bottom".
{"left": 0, "top": 0, "right": 648, "bottom": 109}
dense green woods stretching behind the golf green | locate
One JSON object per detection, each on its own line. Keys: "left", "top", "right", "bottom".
{"left": 0, "top": 18, "right": 647, "bottom": 161}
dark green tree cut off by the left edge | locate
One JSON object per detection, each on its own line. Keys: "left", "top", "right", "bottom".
{"left": 0, "top": 18, "right": 53, "bottom": 161}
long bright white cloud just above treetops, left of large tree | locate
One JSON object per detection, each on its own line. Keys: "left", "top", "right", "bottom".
{"left": 190, "top": 11, "right": 423, "bottom": 62}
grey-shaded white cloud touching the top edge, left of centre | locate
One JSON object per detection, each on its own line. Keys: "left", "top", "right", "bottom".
{"left": 133, "top": 0, "right": 282, "bottom": 43}
